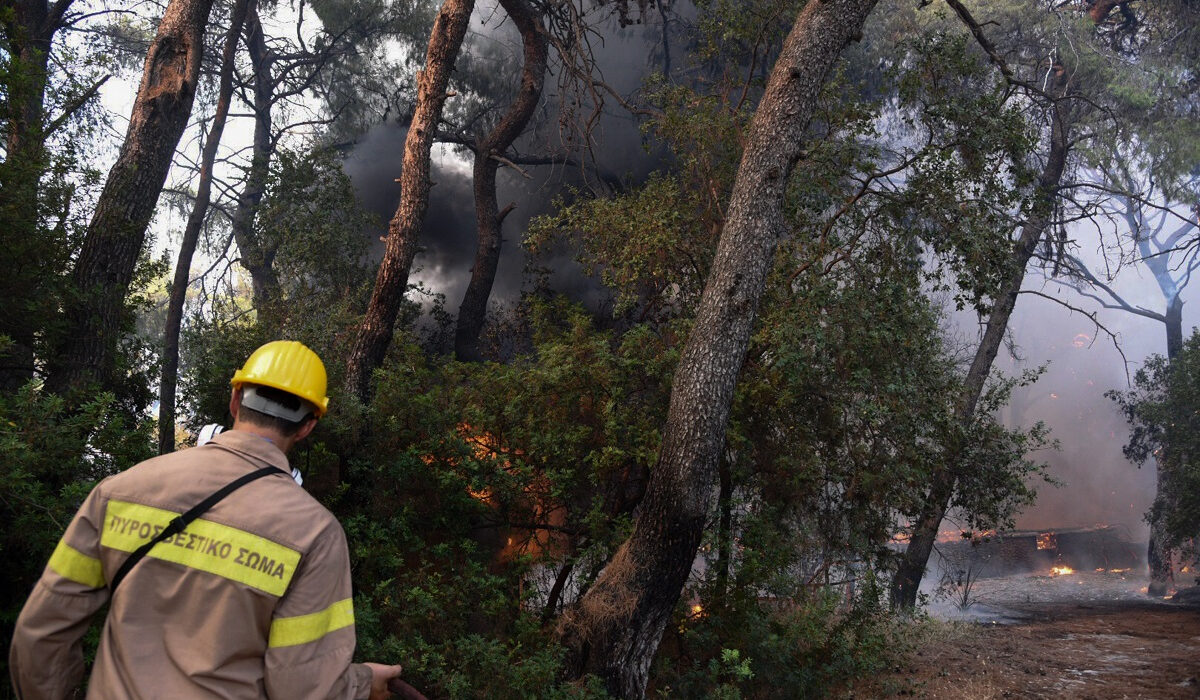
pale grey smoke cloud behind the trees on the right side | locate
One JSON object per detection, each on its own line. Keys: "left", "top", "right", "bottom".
{"left": 996, "top": 273, "right": 1200, "bottom": 537}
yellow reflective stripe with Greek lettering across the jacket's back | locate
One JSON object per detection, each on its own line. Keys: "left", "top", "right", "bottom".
{"left": 100, "top": 501, "right": 300, "bottom": 596}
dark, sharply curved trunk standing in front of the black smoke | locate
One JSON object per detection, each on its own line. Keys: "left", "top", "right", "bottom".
{"left": 455, "top": 0, "right": 547, "bottom": 361}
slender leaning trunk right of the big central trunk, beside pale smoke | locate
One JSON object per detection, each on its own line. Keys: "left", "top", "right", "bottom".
{"left": 892, "top": 65, "right": 1070, "bottom": 608}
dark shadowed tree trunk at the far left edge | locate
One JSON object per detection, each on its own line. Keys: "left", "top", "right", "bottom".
{"left": 0, "top": 0, "right": 72, "bottom": 393}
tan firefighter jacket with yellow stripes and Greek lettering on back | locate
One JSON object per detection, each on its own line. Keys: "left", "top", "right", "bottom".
{"left": 10, "top": 431, "right": 371, "bottom": 700}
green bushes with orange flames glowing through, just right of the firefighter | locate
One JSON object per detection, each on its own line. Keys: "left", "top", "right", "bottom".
{"left": 314, "top": 314, "right": 670, "bottom": 698}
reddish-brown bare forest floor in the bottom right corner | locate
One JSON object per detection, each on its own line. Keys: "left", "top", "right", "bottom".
{"left": 844, "top": 573, "right": 1200, "bottom": 700}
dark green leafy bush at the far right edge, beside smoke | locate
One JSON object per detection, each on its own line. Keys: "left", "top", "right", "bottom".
{"left": 1105, "top": 330, "right": 1200, "bottom": 545}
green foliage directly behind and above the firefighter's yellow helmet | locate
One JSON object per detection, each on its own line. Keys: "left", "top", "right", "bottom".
{"left": 180, "top": 149, "right": 373, "bottom": 429}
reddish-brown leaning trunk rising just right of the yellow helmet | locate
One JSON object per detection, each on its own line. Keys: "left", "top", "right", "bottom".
{"left": 346, "top": 0, "right": 475, "bottom": 396}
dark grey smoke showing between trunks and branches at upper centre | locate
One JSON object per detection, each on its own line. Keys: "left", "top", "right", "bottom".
{"left": 344, "top": 8, "right": 661, "bottom": 311}
